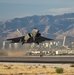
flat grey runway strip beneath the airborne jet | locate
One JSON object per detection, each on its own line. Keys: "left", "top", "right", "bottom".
{"left": 0, "top": 56, "right": 74, "bottom": 63}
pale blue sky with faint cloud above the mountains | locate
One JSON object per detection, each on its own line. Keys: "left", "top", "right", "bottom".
{"left": 0, "top": 0, "right": 74, "bottom": 22}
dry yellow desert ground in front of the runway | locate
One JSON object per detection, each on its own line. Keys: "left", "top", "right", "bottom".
{"left": 0, "top": 62, "right": 74, "bottom": 75}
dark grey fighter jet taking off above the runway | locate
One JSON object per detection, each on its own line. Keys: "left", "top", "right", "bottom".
{"left": 7, "top": 28, "right": 53, "bottom": 45}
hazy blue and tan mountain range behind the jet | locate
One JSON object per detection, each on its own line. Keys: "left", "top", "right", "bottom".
{"left": 0, "top": 13, "right": 74, "bottom": 40}
